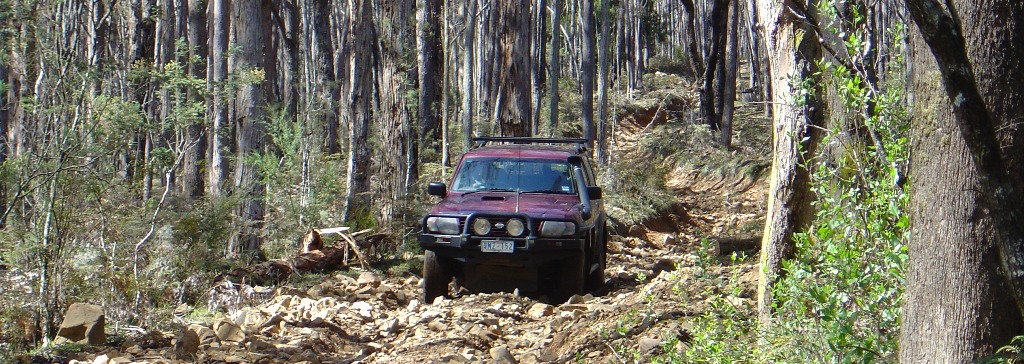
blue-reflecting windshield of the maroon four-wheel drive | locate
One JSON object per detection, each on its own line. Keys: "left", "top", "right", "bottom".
{"left": 452, "top": 158, "right": 575, "bottom": 194}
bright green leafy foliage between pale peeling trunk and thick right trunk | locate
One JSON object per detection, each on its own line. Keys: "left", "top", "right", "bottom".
{"left": 761, "top": 11, "right": 909, "bottom": 363}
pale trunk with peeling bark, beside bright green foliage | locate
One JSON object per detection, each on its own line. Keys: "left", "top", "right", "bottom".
{"left": 758, "top": 0, "right": 820, "bottom": 329}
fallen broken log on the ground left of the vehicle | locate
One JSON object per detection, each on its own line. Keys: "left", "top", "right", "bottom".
{"left": 213, "top": 227, "right": 387, "bottom": 286}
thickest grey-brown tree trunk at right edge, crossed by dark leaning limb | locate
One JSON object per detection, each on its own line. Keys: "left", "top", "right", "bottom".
{"left": 900, "top": 0, "right": 1024, "bottom": 363}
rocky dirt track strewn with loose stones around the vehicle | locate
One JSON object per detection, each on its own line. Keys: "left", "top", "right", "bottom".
{"left": 59, "top": 162, "right": 764, "bottom": 363}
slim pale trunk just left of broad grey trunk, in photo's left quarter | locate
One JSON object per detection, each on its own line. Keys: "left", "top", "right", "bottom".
{"left": 206, "top": 0, "right": 231, "bottom": 198}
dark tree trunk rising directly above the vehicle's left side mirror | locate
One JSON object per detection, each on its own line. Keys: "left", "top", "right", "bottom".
{"left": 409, "top": 0, "right": 444, "bottom": 181}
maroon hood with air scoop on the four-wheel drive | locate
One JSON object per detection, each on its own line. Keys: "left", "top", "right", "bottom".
{"left": 430, "top": 192, "right": 580, "bottom": 219}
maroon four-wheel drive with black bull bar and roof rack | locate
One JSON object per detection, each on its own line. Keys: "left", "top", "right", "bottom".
{"left": 419, "top": 137, "right": 607, "bottom": 302}
